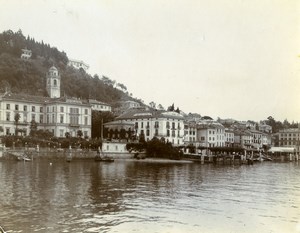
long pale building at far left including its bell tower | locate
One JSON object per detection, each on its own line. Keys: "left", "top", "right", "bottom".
{"left": 0, "top": 67, "right": 92, "bottom": 137}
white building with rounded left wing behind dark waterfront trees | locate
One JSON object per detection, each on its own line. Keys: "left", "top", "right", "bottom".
{"left": 108, "top": 109, "right": 184, "bottom": 146}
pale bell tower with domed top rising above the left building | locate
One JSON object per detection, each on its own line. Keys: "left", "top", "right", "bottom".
{"left": 47, "top": 66, "right": 60, "bottom": 98}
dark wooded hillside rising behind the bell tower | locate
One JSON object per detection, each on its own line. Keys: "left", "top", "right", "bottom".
{"left": 0, "top": 30, "right": 131, "bottom": 104}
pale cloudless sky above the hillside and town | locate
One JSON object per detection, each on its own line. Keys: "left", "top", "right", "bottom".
{"left": 0, "top": 0, "right": 300, "bottom": 122}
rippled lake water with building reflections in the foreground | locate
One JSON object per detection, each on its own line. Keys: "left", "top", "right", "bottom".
{"left": 0, "top": 160, "right": 300, "bottom": 233}
